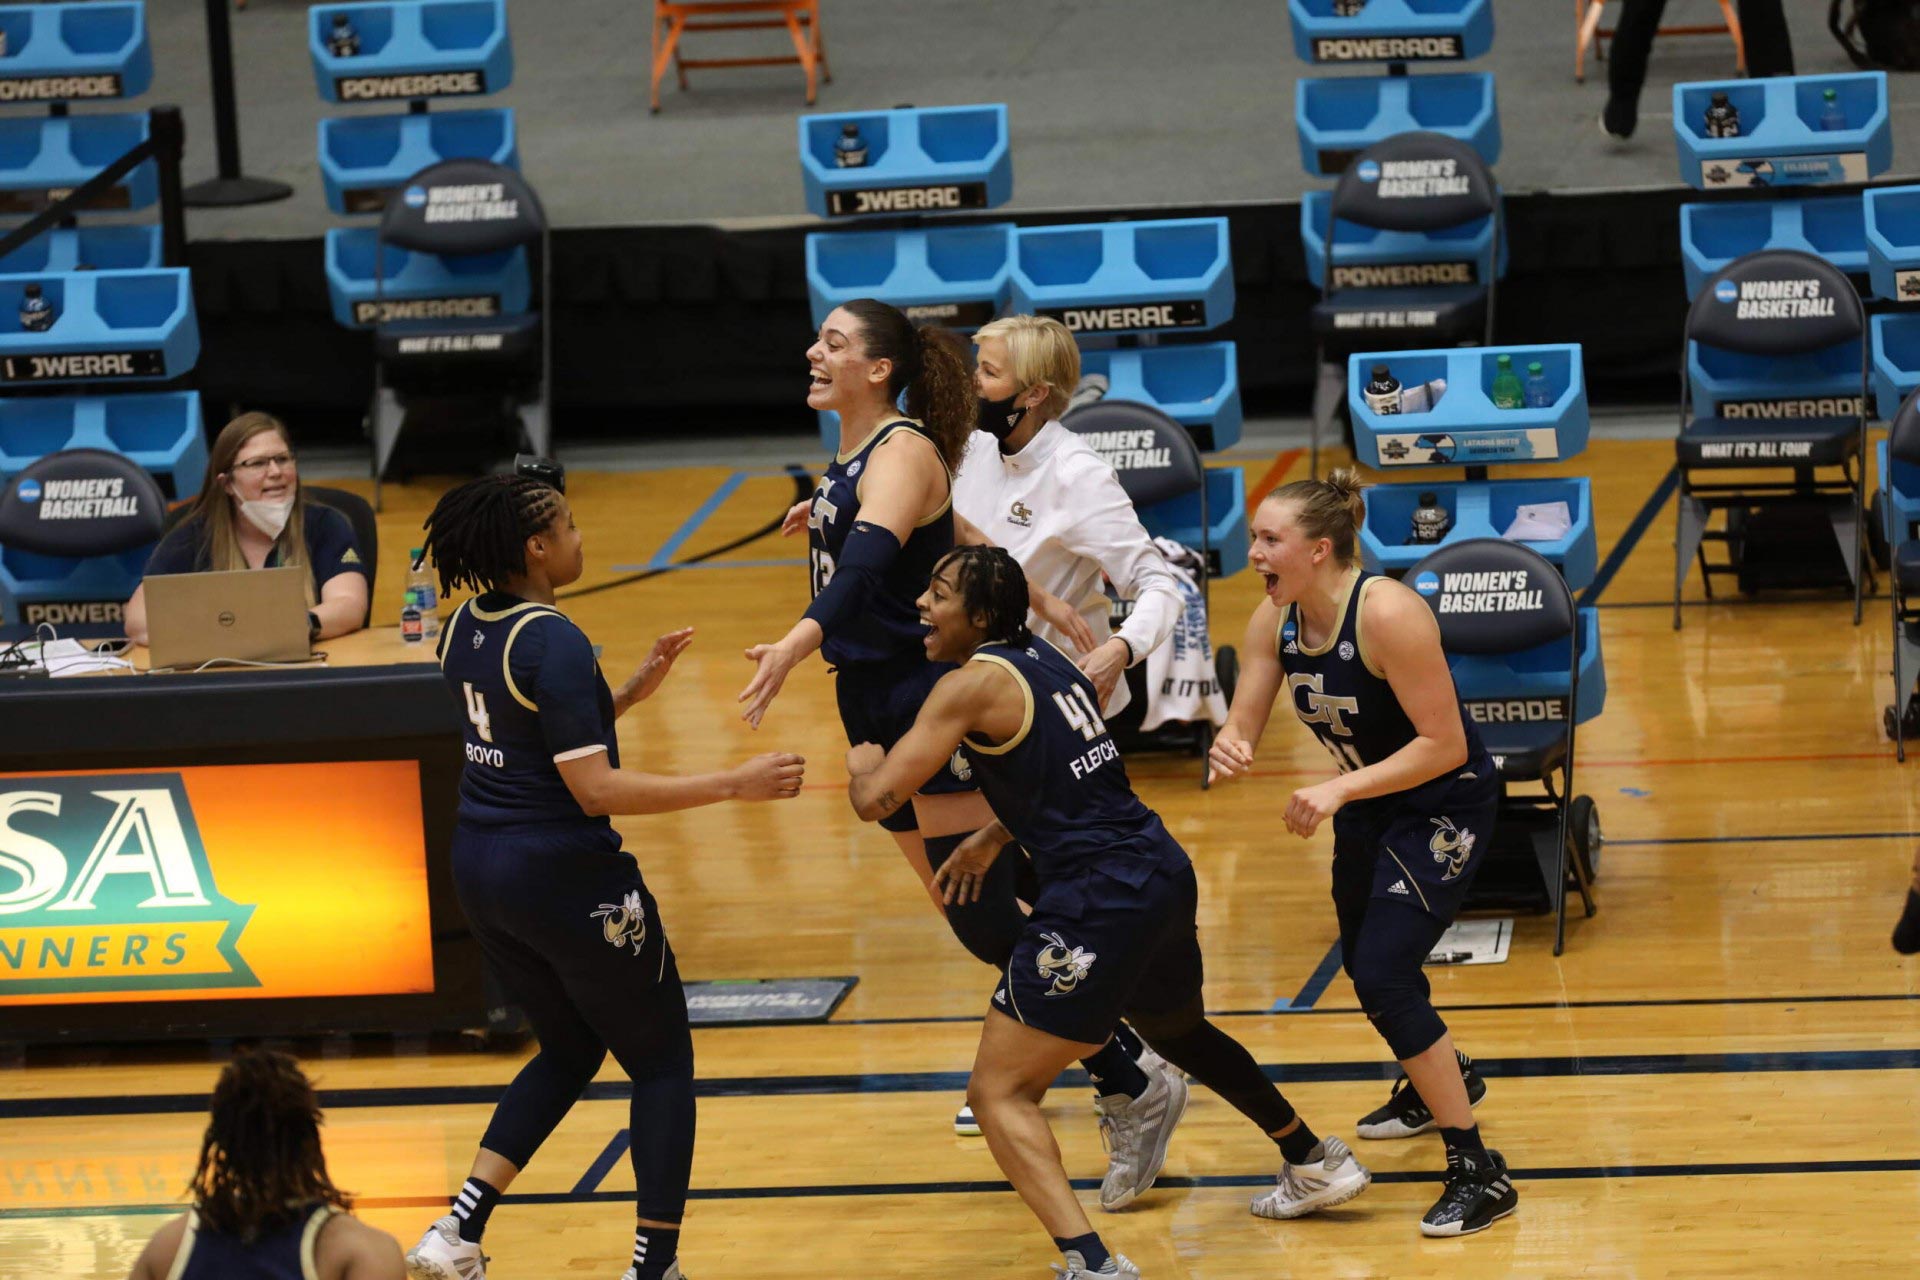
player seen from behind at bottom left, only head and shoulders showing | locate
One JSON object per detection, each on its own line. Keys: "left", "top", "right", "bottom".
{"left": 131, "top": 1050, "right": 407, "bottom": 1280}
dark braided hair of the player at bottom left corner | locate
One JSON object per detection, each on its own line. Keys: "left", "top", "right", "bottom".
{"left": 188, "top": 1050, "right": 353, "bottom": 1242}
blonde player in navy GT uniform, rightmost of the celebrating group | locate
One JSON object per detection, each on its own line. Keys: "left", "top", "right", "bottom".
{"left": 1212, "top": 470, "right": 1519, "bottom": 1236}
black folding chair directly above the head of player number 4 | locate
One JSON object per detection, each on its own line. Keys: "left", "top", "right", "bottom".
{"left": 369, "top": 159, "right": 553, "bottom": 510}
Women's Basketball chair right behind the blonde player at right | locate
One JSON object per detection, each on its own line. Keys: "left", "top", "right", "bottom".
{"left": 1404, "top": 537, "right": 1599, "bottom": 956}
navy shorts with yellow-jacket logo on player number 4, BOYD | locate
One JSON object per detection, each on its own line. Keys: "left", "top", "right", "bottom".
{"left": 453, "top": 825, "right": 693, "bottom": 1079}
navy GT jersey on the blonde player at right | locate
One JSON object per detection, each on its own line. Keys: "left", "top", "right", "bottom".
{"left": 1275, "top": 570, "right": 1482, "bottom": 773}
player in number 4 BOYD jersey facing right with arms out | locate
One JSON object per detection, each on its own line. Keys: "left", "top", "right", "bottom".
{"left": 407, "top": 476, "right": 804, "bottom": 1280}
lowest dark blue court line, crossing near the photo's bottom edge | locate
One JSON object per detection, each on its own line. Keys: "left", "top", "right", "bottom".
{"left": 11, "top": 1159, "right": 1920, "bottom": 1222}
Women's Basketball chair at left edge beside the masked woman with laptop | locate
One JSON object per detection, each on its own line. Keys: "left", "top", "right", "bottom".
{"left": 0, "top": 449, "right": 167, "bottom": 635}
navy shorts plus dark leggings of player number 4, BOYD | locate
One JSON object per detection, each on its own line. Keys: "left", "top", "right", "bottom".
{"left": 453, "top": 825, "right": 693, "bottom": 1222}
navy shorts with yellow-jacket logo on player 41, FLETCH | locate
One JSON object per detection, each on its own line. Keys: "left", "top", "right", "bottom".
{"left": 989, "top": 862, "right": 1206, "bottom": 1044}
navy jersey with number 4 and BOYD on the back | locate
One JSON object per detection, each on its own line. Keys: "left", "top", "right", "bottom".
{"left": 440, "top": 591, "right": 620, "bottom": 829}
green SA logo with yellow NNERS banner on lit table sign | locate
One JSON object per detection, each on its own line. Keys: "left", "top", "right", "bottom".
{"left": 0, "top": 773, "right": 259, "bottom": 996}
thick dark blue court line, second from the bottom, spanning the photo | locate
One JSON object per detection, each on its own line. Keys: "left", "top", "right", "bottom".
{"left": 15, "top": 1048, "right": 1920, "bottom": 1121}
